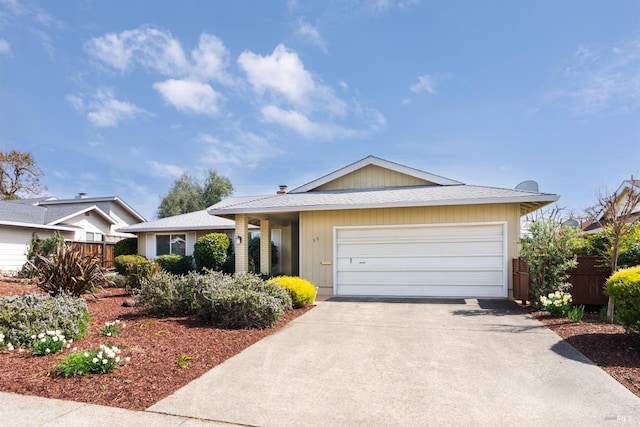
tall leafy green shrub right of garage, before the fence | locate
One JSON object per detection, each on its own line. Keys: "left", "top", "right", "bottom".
{"left": 521, "top": 213, "right": 578, "bottom": 307}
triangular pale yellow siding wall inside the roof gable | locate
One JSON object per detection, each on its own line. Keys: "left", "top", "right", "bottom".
{"left": 314, "top": 165, "right": 434, "bottom": 191}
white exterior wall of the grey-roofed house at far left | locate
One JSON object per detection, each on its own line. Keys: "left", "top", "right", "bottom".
{"left": 0, "top": 225, "right": 73, "bottom": 273}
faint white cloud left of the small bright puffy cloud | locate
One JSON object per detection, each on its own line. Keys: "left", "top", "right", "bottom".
{"left": 82, "top": 89, "right": 150, "bottom": 127}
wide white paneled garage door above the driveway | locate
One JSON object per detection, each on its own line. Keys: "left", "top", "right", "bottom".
{"left": 334, "top": 223, "right": 507, "bottom": 298}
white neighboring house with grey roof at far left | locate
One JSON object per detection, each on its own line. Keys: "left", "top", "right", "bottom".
{"left": 0, "top": 195, "right": 145, "bottom": 272}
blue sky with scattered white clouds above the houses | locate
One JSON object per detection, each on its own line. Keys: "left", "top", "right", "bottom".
{"left": 0, "top": 0, "right": 640, "bottom": 219}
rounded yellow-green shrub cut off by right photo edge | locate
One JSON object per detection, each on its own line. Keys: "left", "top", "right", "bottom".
{"left": 605, "top": 266, "right": 640, "bottom": 332}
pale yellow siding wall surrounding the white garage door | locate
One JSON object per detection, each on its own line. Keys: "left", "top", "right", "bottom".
{"left": 299, "top": 203, "right": 520, "bottom": 297}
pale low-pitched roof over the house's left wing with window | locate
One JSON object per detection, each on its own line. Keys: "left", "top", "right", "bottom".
{"left": 118, "top": 210, "right": 250, "bottom": 233}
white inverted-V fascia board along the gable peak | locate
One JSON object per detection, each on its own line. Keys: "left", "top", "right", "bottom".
{"left": 289, "top": 156, "right": 463, "bottom": 193}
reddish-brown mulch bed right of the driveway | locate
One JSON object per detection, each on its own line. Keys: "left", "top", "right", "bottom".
{"left": 531, "top": 311, "right": 640, "bottom": 397}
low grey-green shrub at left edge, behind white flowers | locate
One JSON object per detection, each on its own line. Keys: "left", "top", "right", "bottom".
{"left": 0, "top": 294, "right": 91, "bottom": 345}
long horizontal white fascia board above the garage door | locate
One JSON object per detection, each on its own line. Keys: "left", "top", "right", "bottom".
{"left": 210, "top": 195, "right": 560, "bottom": 215}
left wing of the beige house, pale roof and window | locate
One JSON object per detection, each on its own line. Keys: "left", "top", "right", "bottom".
{"left": 120, "top": 210, "right": 258, "bottom": 259}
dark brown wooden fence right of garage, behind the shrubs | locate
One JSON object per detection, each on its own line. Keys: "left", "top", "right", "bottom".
{"left": 512, "top": 257, "right": 611, "bottom": 305}
